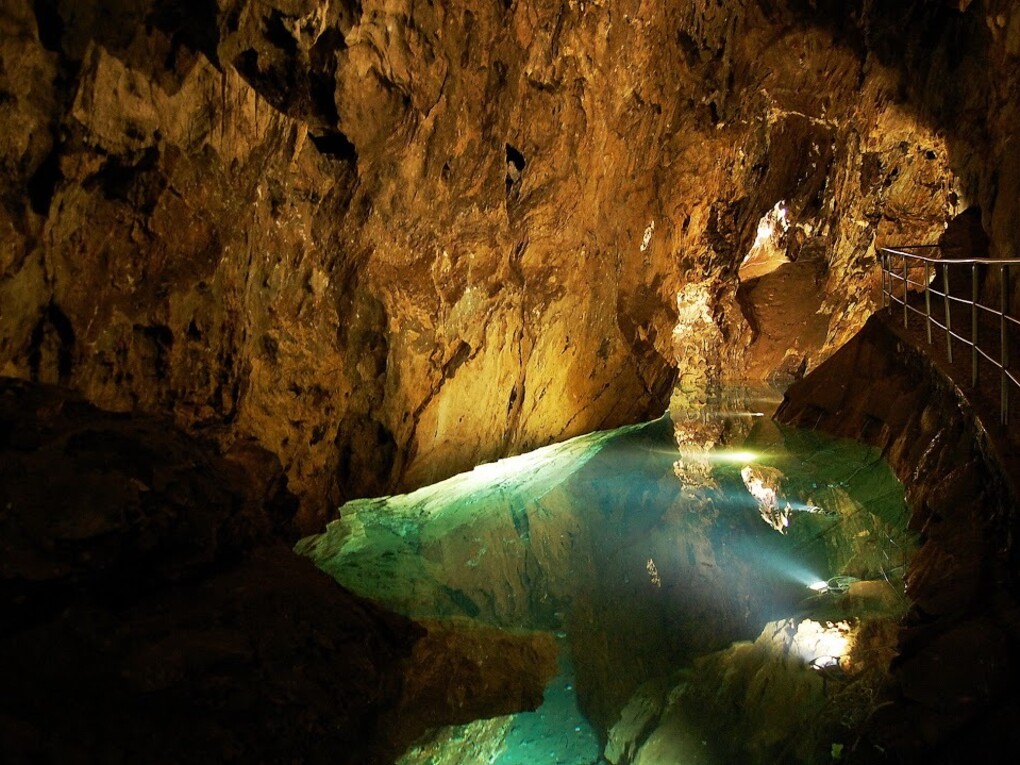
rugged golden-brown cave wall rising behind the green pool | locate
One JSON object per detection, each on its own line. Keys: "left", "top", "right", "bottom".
{"left": 0, "top": 0, "right": 1020, "bottom": 527}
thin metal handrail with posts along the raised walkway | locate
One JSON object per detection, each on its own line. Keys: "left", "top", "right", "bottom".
{"left": 878, "top": 245, "right": 1020, "bottom": 425}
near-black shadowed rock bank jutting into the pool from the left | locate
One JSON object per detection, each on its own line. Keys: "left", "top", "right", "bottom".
{"left": 0, "top": 377, "right": 556, "bottom": 765}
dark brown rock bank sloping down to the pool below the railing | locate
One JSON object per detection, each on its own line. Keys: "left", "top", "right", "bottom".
{"left": 776, "top": 318, "right": 1020, "bottom": 763}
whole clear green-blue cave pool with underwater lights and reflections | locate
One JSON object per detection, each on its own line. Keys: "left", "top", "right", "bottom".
{"left": 298, "top": 389, "right": 916, "bottom": 765}
